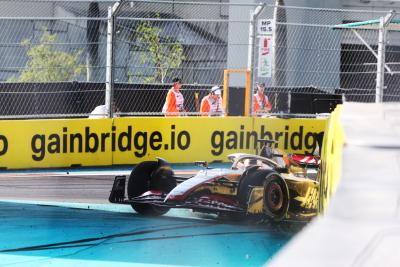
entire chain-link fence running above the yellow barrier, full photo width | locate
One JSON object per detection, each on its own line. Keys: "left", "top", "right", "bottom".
{"left": 0, "top": 0, "right": 400, "bottom": 118}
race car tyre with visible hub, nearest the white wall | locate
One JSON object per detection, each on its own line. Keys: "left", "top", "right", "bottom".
{"left": 264, "top": 172, "right": 289, "bottom": 221}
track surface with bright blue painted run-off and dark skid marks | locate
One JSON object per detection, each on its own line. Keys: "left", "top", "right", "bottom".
{"left": 0, "top": 172, "right": 301, "bottom": 267}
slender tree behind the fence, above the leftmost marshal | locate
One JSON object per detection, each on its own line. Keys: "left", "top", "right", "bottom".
{"left": 137, "top": 21, "right": 185, "bottom": 83}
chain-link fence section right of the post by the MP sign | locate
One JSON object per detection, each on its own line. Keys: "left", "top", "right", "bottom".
{"left": 253, "top": 4, "right": 400, "bottom": 112}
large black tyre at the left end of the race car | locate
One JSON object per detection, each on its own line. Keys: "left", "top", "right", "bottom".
{"left": 127, "top": 161, "right": 176, "bottom": 216}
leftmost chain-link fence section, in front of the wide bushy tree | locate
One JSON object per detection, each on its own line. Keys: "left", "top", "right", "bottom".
{"left": 0, "top": 0, "right": 114, "bottom": 118}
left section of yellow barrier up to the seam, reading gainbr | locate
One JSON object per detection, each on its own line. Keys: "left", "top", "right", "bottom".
{"left": 0, "top": 119, "right": 112, "bottom": 169}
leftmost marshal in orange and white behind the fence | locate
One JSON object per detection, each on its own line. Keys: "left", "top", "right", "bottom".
{"left": 162, "top": 78, "right": 185, "bottom": 117}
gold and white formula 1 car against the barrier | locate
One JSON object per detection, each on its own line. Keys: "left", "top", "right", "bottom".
{"left": 109, "top": 140, "right": 319, "bottom": 221}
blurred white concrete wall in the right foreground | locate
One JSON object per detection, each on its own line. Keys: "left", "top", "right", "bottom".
{"left": 268, "top": 103, "right": 400, "bottom": 267}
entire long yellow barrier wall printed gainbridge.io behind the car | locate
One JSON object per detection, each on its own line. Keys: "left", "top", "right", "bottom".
{"left": 0, "top": 117, "right": 326, "bottom": 169}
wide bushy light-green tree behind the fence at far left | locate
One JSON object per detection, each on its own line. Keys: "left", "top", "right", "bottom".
{"left": 16, "top": 29, "right": 85, "bottom": 82}
